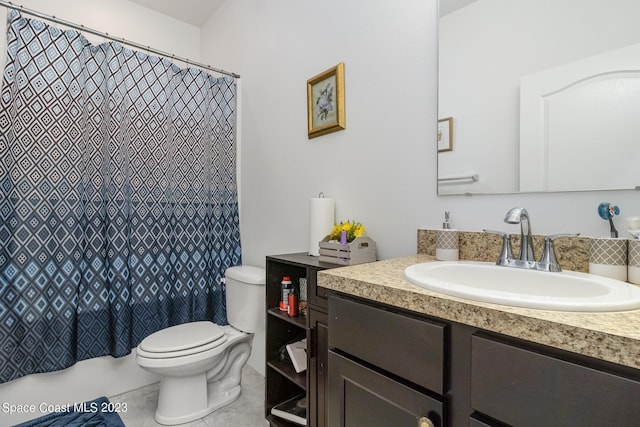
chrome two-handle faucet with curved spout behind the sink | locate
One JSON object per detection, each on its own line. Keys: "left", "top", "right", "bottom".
{"left": 483, "top": 208, "right": 579, "bottom": 272}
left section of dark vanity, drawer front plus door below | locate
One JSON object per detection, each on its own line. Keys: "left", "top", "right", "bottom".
{"left": 328, "top": 295, "right": 445, "bottom": 427}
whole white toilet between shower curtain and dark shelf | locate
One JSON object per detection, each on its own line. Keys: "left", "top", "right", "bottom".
{"left": 136, "top": 266, "right": 265, "bottom": 425}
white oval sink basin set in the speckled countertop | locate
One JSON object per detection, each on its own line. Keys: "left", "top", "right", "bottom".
{"left": 404, "top": 261, "right": 640, "bottom": 312}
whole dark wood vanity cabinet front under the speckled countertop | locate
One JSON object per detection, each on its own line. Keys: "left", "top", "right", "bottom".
{"left": 328, "top": 295, "right": 640, "bottom": 427}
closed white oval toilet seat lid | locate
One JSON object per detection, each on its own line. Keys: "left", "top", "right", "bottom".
{"left": 137, "top": 321, "right": 227, "bottom": 359}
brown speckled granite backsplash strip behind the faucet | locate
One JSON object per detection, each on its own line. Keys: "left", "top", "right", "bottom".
{"left": 418, "top": 230, "right": 590, "bottom": 273}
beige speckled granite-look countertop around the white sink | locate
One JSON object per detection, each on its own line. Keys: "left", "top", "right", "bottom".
{"left": 318, "top": 255, "right": 640, "bottom": 369}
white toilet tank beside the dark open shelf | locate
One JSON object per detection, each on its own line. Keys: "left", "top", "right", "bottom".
{"left": 225, "top": 265, "right": 265, "bottom": 333}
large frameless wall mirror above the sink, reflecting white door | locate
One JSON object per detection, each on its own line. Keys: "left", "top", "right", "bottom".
{"left": 438, "top": 0, "right": 640, "bottom": 195}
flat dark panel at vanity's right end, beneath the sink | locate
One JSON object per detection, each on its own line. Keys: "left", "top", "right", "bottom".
{"left": 471, "top": 335, "right": 640, "bottom": 427}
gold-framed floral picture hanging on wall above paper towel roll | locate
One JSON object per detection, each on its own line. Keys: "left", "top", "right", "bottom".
{"left": 307, "top": 62, "right": 346, "bottom": 139}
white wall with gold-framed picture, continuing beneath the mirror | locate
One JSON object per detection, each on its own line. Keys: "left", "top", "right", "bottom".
{"left": 202, "top": 0, "right": 640, "bottom": 369}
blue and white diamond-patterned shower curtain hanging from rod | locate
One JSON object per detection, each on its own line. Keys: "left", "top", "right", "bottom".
{"left": 0, "top": 11, "right": 241, "bottom": 382}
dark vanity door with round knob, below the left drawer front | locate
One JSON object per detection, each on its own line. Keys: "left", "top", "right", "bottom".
{"left": 328, "top": 351, "right": 443, "bottom": 427}
